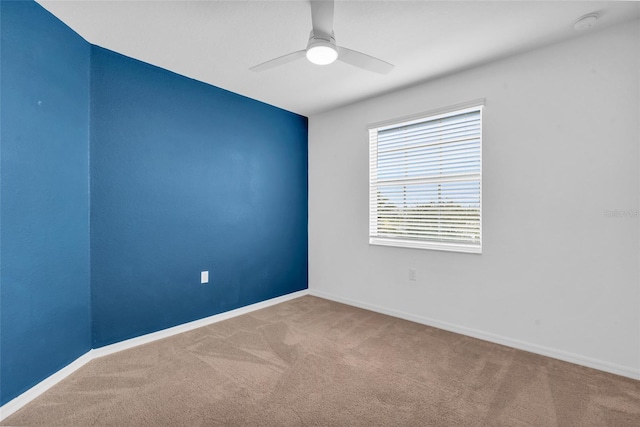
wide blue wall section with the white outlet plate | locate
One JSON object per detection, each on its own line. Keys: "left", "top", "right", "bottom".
{"left": 91, "top": 47, "right": 307, "bottom": 347}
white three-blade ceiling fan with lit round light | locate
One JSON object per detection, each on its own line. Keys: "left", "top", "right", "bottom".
{"left": 249, "top": 0, "right": 393, "bottom": 74}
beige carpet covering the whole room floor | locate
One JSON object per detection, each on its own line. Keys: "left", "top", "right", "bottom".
{"left": 3, "top": 296, "right": 640, "bottom": 427}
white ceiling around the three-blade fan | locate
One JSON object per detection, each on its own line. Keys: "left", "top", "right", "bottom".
{"left": 39, "top": 0, "right": 640, "bottom": 116}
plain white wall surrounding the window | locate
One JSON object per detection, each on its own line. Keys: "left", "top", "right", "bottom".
{"left": 309, "top": 20, "right": 640, "bottom": 377}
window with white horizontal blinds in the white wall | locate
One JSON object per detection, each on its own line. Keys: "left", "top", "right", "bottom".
{"left": 369, "top": 103, "right": 482, "bottom": 253}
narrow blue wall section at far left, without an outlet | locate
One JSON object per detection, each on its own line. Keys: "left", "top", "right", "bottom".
{"left": 0, "top": 1, "right": 91, "bottom": 404}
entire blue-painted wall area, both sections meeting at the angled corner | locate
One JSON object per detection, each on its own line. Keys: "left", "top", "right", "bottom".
{"left": 0, "top": 1, "right": 307, "bottom": 405}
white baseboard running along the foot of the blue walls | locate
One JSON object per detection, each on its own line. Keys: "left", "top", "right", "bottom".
{"left": 0, "top": 289, "right": 309, "bottom": 421}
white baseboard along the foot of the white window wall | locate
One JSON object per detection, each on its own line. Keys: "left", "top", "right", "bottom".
{"left": 309, "top": 289, "right": 640, "bottom": 380}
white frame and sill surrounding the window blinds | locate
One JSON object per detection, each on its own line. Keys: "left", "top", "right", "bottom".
{"left": 367, "top": 99, "right": 485, "bottom": 254}
